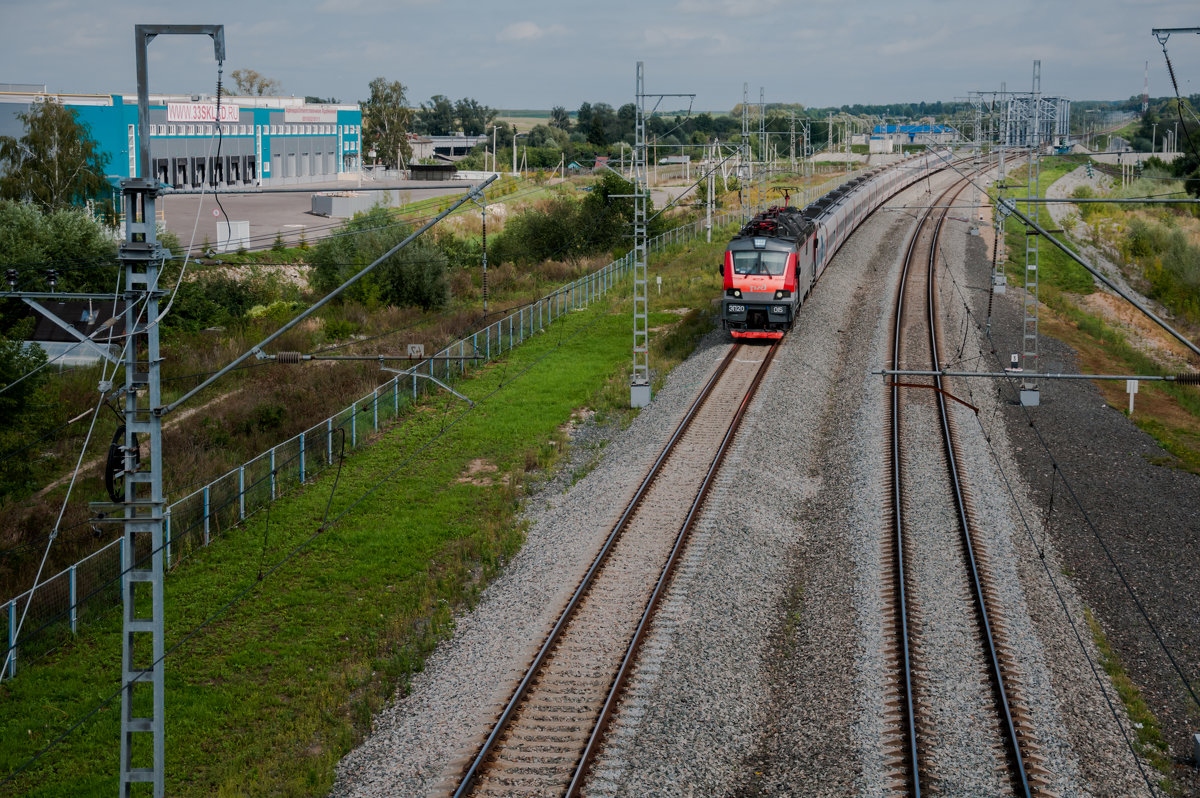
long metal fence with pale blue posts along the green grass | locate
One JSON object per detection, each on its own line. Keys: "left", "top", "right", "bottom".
{"left": 0, "top": 168, "right": 851, "bottom": 680}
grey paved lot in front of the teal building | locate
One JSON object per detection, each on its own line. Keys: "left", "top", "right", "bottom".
{"left": 158, "top": 180, "right": 472, "bottom": 250}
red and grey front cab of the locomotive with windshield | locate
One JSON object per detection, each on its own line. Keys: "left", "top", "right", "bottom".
{"left": 721, "top": 238, "right": 797, "bottom": 338}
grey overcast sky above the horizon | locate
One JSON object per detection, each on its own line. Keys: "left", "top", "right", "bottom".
{"left": 0, "top": 0, "right": 1200, "bottom": 110}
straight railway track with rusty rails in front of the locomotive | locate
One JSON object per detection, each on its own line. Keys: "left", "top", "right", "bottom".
{"left": 443, "top": 338, "right": 776, "bottom": 798}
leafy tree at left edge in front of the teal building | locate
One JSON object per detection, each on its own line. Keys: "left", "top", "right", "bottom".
{"left": 0, "top": 102, "right": 109, "bottom": 210}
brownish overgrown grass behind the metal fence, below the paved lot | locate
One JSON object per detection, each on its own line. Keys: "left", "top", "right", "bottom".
{"left": 0, "top": 172, "right": 608, "bottom": 596}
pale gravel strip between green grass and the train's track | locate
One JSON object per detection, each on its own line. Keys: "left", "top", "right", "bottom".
{"left": 330, "top": 321, "right": 727, "bottom": 797}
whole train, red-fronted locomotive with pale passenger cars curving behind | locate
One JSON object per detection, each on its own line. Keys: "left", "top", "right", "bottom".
{"left": 721, "top": 151, "right": 949, "bottom": 338}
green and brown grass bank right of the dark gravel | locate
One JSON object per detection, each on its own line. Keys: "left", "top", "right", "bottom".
{"left": 1004, "top": 160, "right": 1200, "bottom": 473}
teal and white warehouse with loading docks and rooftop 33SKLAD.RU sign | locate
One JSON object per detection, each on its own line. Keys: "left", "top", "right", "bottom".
{"left": 0, "top": 84, "right": 362, "bottom": 191}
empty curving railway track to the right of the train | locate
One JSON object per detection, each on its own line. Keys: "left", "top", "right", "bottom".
{"left": 883, "top": 169, "right": 1049, "bottom": 797}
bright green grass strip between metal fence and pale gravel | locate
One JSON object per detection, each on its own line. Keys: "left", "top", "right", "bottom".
{"left": 0, "top": 236, "right": 722, "bottom": 796}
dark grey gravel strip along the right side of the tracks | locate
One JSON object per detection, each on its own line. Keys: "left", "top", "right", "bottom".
{"left": 977, "top": 247, "right": 1200, "bottom": 796}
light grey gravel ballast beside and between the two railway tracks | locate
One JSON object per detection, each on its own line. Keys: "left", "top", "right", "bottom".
{"left": 331, "top": 162, "right": 1171, "bottom": 797}
